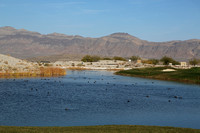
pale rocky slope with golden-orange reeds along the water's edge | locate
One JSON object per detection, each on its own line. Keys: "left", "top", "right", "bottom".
{"left": 0, "top": 54, "right": 66, "bottom": 78}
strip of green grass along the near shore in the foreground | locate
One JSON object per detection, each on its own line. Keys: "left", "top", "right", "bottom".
{"left": 0, "top": 125, "right": 200, "bottom": 133}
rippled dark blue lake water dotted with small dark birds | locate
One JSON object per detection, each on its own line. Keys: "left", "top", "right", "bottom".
{"left": 0, "top": 71, "right": 200, "bottom": 129}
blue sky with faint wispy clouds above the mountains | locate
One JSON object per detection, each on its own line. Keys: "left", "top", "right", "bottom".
{"left": 0, "top": 0, "right": 200, "bottom": 41}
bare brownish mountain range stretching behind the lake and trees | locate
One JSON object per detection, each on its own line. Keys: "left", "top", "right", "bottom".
{"left": 0, "top": 27, "right": 200, "bottom": 60}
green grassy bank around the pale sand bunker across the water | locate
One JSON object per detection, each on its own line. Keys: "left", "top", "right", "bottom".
{"left": 116, "top": 67, "right": 200, "bottom": 84}
